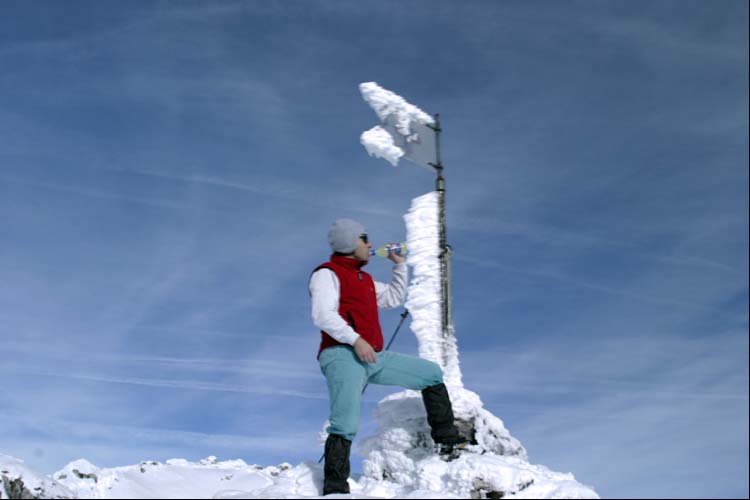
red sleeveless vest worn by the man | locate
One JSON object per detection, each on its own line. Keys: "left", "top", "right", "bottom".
{"left": 313, "top": 255, "right": 383, "bottom": 356}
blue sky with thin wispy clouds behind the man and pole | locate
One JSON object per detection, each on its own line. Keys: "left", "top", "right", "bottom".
{"left": 0, "top": 0, "right": 748, "bottom": 498}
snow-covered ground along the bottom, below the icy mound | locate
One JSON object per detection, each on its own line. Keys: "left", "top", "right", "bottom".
{"left": 0, "top": 454, "right": 598, "bottom": 498}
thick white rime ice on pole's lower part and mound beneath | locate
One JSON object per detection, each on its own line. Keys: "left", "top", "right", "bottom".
{"left": 352, "top": 192, "right": 598, "bottom": 498}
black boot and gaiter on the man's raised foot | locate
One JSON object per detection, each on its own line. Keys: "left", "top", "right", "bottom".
{"left": 422, "top": 384, "right": 469, "bottom": 461}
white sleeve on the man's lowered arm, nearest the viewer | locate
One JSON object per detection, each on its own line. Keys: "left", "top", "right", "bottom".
{"left": 310, "top": 268, "right": 359, "bottom": 346}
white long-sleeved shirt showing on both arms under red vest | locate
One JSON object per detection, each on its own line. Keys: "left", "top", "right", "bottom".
{"left": 309, "top": 263, "right": 408, "bottom": 345}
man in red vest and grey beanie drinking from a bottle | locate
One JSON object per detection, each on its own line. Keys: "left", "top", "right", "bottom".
{"left": 309, "top": 219, "right": 466, "bottom": 495}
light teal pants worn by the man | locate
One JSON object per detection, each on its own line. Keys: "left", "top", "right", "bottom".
{"left": 318, "top": 345, "right": 443, "bottom": 441}
